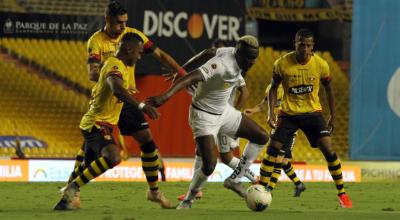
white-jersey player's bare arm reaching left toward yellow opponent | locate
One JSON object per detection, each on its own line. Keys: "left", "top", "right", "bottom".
{"left": 146, "top": 69, "right": 203, "bottom": 107}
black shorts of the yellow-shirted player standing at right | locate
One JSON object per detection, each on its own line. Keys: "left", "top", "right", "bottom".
{"left": 271, "top": 112, "right": 330, "bottom": 147}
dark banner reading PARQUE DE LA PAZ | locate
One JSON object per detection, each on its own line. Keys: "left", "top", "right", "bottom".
{"left": 0, "top": 12, "right": 103, "bottom": 40}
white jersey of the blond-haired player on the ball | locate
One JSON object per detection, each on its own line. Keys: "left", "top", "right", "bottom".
{"left": 192, "top": 47, "right": 244, "bottom": 114}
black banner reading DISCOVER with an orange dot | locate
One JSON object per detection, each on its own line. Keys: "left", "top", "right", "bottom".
{"left": 126, "top": 0, "right": 245, "bottom": 73}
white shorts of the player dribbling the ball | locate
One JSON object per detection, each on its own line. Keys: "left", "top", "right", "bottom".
{"left": 189, "top": 105, "right": 242, "bottom": 143}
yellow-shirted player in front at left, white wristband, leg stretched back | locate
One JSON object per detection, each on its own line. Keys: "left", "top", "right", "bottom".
{"left": 54, "top": 33, "right": 159, "bottom": 210}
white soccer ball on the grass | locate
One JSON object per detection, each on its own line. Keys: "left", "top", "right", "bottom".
{"left": 246, "top": 184, "right": 272, "bottom": 212}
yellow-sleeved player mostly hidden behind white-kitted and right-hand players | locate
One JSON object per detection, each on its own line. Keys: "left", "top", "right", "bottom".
{"left": 244, "top": 84, "right": 306, "bottom": 197}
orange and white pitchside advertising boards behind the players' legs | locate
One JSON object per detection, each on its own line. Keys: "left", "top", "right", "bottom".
{"left": 0, "top": 160, "right": 361, "bottom": 182}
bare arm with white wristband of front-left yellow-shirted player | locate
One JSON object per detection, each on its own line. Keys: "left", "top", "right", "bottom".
{"left": 107, "top": 75, "right": 160, "bottom": 120}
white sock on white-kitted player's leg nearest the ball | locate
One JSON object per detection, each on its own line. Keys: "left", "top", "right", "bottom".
{"left": 230, "top": 142, "right": 264, "bottom": 182}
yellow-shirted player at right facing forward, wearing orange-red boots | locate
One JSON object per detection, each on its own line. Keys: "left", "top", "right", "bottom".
{"left": 260, "top": 29, "right": 353, "bottom": 208}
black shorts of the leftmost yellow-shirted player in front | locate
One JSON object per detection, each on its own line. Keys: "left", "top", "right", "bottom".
{"left": 81, "top": 125, "right": 115, "bottom": 163}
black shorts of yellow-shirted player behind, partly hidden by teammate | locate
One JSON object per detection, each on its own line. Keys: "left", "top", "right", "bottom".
{"left": 118, "top": 103, "right": 149, "bottom": 135}
